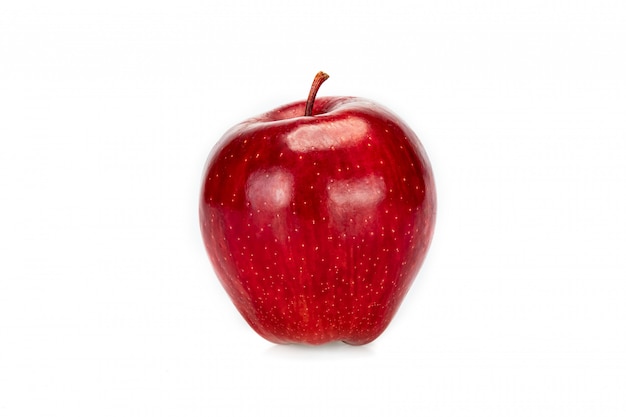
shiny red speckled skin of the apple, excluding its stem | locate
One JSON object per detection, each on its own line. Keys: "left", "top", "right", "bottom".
{"left": 200, "top": 97, "right": 436, "bottom": 345}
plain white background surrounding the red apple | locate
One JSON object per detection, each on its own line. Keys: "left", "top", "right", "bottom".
{"left": 0, "top": 0, "right": 626, "bottom": 417}
